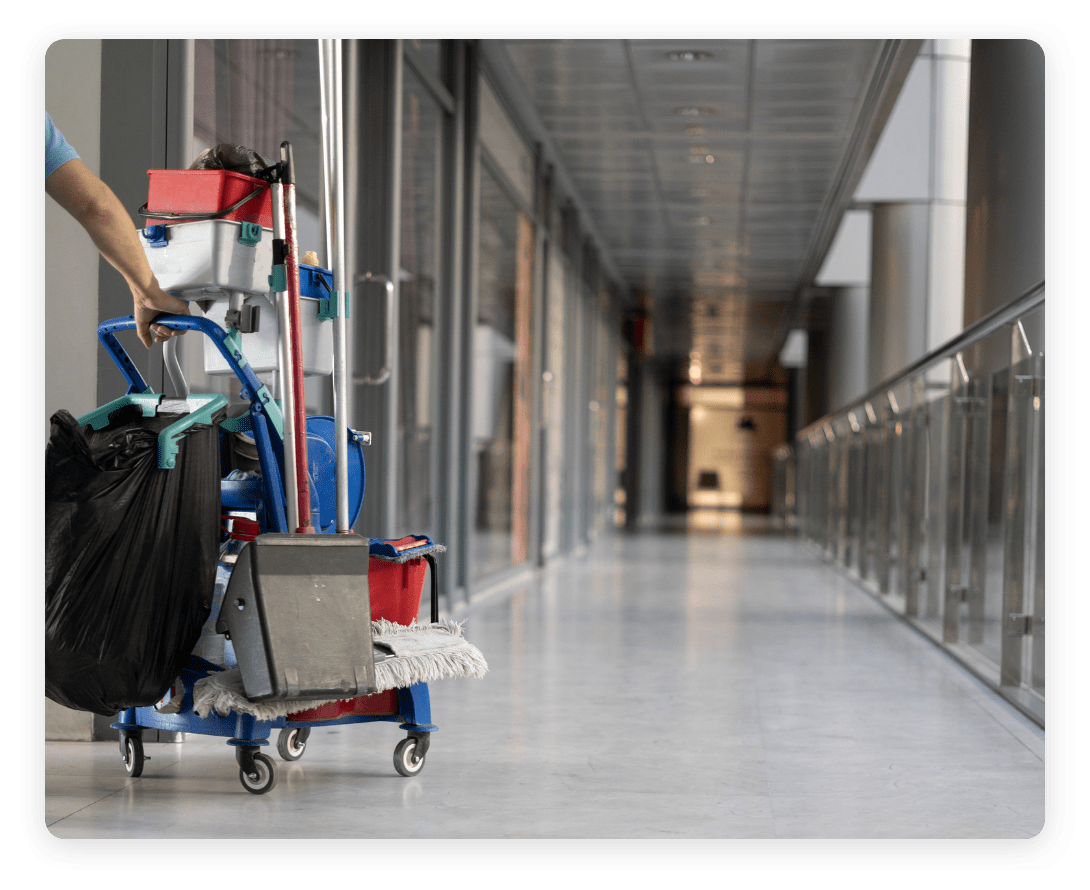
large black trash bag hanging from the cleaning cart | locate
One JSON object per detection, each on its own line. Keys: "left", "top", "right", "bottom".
{"left": 46, "top": 406, "right": 222, "bottom": 717}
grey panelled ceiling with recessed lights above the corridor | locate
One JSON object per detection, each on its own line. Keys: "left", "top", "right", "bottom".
{"left": 482, "top": 38, "right": 921, "bottom": 382}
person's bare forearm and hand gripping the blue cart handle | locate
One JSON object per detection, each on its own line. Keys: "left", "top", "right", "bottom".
{"left": 46, "top": 158, "right": 190, "bottom": 349}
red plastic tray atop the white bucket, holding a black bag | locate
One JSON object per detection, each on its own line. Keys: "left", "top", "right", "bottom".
{"left": 145, "top": 170, "right": 273, "bottom": 229}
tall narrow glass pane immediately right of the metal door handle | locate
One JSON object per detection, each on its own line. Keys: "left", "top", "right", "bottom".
{"left": 398, "top": 66, "right": 444, "bottom": 534}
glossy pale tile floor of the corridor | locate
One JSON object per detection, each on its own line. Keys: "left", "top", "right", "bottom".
{"left": 46, "top": 516, "right": 1044, "bottom": 839}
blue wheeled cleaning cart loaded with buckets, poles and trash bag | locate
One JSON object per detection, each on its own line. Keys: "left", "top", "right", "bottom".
{"left": 47, "top": 40, "right": 487, "bottom": 794}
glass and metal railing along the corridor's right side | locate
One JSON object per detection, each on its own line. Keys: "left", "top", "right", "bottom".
{"left": 776, "top": 286, "right": 1045, "bottom": 724}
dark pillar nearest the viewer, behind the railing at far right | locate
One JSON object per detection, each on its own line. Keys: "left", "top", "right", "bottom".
{"left": 965, "top": 39, "right": 1045, "bottom": 346}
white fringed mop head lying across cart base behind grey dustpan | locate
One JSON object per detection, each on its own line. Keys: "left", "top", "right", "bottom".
{"left": 193, "top": 619, "right": 488, "bottom": 720}
